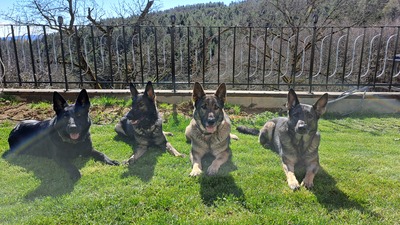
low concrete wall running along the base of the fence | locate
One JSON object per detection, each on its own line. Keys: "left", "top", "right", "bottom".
{"left": 0, "top": 89, "right": 400, "bottom": 114}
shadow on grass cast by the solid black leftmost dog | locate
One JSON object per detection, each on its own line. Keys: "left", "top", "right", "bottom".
{"left": 2, "top": 152, "right": 83, "bottom": 201}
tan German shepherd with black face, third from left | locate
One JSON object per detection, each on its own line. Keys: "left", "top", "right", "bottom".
{"left": 185, "top": 82, "right": 237, "bottom": 176}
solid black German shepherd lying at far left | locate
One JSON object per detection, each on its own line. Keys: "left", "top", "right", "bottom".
{"left": 3, "top": 89, "right": 119, "bottom": 179}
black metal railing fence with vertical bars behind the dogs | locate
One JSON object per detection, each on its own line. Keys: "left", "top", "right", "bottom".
{"left": 0, "top": 24, "right": 400, "bottom": 92}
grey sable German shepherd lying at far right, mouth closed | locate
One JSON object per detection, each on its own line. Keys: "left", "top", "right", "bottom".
{"left": 237, "top": 89, "right": 328, "bottom": 190}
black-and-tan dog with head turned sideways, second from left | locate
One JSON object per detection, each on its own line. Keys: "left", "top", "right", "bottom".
{"left": 115, "top": 81, "right": 184, "bottom": 164}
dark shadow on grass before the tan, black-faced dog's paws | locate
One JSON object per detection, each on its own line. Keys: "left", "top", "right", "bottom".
{"left": 199, "top": 154, "right": 246, "bottom": 206}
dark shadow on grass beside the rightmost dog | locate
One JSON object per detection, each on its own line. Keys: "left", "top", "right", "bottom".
{"left": 310, "top": 168, "right": 381, "bottom": 217}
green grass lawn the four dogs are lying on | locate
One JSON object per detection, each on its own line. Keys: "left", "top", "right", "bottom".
{"left": 0, "top": 104, "right": 400, "bottom": 224}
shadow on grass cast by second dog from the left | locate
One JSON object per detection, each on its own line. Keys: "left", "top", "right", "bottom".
{"left": 114, "top": 135, "right": 166, "bottom": 182}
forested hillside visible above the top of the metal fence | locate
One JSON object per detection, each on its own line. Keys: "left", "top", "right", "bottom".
{"left": 105, "top": 0, "right": 400, "bottom": 27}
